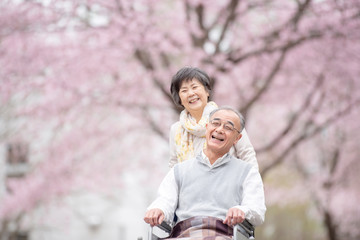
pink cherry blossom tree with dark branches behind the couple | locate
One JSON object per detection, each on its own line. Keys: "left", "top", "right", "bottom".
{"left": 0, "top": 0, "right": 360, "bottom": 240}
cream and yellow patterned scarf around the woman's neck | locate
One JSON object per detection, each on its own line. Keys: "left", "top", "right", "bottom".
{"left": 175, "top": 102, "right": 218, "bottom": 162}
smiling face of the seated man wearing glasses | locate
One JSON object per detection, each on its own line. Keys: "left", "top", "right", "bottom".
{"left": 206, "top": 110, "right": 241, "bottom": 155}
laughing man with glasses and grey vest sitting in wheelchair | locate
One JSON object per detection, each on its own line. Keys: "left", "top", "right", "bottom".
{"left": 144, "top": 107, "right": 266, "bottom": 239}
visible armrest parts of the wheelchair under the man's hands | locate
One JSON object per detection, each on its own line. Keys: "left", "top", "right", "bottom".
{"left": 148, "top": 219, "right": 255, "bottom": 240}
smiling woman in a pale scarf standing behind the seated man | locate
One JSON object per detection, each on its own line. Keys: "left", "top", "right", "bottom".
{"left": 169, "top": 67, "right": 258, "bottom": 168}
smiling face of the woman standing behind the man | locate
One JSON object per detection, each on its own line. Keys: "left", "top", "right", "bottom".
{"left": 179, "top": 78, "right": 209, "bottom": 115}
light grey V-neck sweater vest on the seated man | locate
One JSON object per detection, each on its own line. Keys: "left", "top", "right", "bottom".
{"left": 174, "top": 154, "right": 251, "bottom": 221}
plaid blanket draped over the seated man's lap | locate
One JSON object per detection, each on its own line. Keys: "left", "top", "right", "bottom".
{"left": 164, "top": 217, "right": 233, "bottom": 240}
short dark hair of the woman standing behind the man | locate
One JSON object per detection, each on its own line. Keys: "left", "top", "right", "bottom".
{"left": 170, "top": 67, "right": 211, "bottom": 107}
